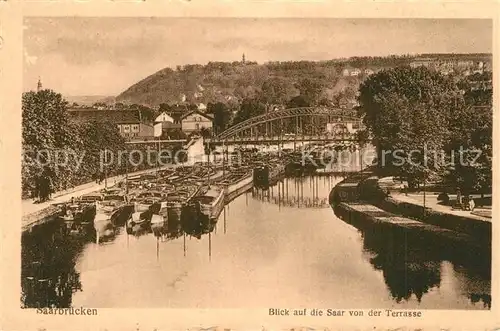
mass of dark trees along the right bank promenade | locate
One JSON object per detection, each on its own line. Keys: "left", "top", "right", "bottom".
{"left": 359, "top": 67, "right": 493, "bottom": 195}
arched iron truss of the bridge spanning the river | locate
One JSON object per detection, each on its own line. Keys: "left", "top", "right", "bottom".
{"left": 207, "top": 107, "right": 363, "bottom": 144}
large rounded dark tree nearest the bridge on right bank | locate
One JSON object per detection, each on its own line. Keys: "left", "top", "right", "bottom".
{"left": 359, "top": 67, "right": 457, "bottom": 187}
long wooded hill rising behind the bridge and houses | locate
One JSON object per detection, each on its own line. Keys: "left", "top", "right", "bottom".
{"left": 116, "top": 54, "right": 491, "bottom": 107}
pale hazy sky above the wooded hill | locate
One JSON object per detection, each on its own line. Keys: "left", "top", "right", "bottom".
{"left": 23, "top": 17, "right": 493, "bottom": 96}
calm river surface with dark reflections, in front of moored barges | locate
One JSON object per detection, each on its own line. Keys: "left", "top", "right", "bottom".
{"left": 21, "top": 176, "right": 491, "bottom": 309}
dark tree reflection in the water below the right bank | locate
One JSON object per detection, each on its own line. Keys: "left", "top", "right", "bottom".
{"left": 336, "top": 205, "right": 491, "bottom": 308}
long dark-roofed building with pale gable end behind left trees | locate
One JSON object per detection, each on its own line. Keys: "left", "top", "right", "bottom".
{"left": 68, "top": 108, "right": 154, "bottom": 140}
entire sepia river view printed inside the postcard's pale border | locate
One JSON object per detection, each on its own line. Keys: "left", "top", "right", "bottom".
{"left": 20, "top": 16, "right": 494, "bottom": 317}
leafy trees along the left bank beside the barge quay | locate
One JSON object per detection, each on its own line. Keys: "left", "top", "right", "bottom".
{"left": 22, "top": 90, "right": 129, "bottom": 197}
